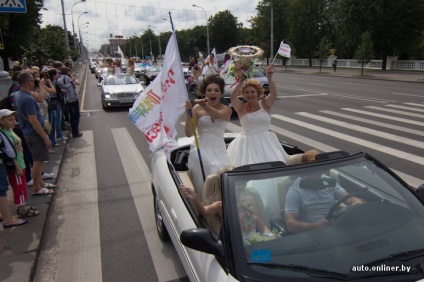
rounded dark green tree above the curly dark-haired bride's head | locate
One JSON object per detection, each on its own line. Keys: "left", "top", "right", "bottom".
{"left": 209, "top": 10, "right": 239, "bottom": 53}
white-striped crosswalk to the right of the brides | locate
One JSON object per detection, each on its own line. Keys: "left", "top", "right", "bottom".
{"left": 181, "top": 101, "right": 424, "bottom": 187}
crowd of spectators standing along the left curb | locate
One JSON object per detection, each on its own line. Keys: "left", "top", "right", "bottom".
{"left": 0, "top": 58, "right": 82, "bottom": 228}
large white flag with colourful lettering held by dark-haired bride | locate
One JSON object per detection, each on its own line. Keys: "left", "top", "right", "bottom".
{"left": 128, "top": 33, "right": 188, "bottom": 151}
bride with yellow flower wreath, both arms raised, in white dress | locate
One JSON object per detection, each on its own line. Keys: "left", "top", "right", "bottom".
{"left": 228, "top": 65, "right": 288, "bottom": 166}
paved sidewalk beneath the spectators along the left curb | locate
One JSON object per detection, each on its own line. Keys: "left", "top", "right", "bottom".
{"left": 0, "top": 65, "right": 86, "bottom": 282}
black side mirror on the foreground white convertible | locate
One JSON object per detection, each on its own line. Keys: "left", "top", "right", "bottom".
{"left": 180, "top": 228, "right": 224, "bottom": 257}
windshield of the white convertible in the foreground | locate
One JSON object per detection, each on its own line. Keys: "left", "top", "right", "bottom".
{"left": 227, "top": 154, "right": 424, "bottom": 277}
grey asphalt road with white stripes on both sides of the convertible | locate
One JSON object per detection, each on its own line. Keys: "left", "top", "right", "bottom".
{"left": 36, "top": 67, "right": 424, "bottom": 282}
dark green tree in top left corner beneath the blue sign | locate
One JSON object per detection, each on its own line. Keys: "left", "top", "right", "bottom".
{"left": 0, "top": 0, "right": 44, "bottom": 70}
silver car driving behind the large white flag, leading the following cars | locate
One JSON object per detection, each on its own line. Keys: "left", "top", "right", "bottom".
{"left": 98, "top": 74, "right": 144, "bottom": 109}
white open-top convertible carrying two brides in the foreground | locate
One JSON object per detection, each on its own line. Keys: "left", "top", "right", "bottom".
{"left": 151, "top": 135, "right": 424, "bottom": 282}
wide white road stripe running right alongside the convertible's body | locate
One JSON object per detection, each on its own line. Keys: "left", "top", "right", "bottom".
{"left": 111, "top": 128, "right": 186, "bottom": 282}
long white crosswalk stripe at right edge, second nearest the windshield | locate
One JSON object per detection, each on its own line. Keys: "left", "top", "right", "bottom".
{"left": 272, "top": 114, "right": 424, "bottom": 165}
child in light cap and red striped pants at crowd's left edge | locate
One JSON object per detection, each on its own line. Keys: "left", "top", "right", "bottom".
{"left": 0, "top": 109, "right": 40, "bottom": 218}
